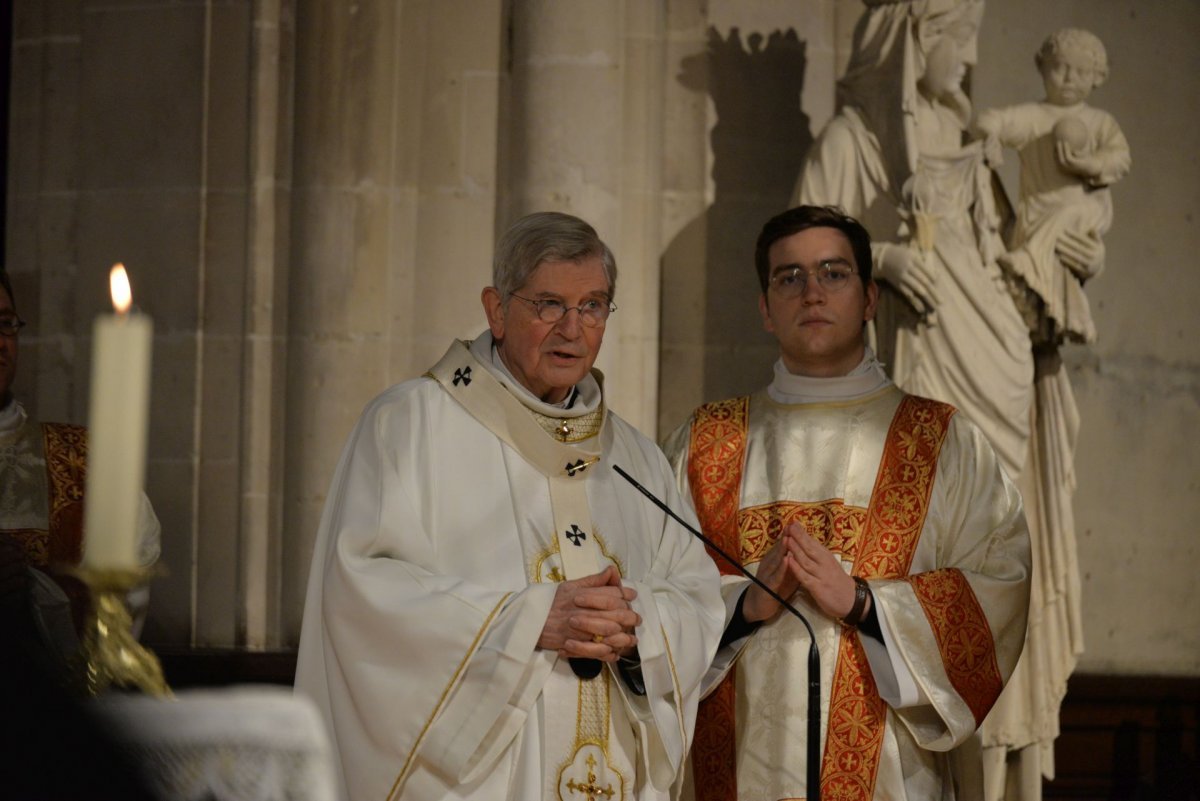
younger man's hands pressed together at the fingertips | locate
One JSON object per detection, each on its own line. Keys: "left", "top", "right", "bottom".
{"left": 742, "top": 523, "right": 870, "bottom": 622}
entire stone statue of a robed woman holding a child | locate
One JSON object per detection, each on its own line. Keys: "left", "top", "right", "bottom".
{"left": 792, "top": 9, "right": 1130, "bottom": 801}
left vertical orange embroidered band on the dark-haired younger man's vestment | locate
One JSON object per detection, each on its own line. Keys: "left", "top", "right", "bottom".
{"left": 688, "top": 397, "right": 750, "bottom": 801}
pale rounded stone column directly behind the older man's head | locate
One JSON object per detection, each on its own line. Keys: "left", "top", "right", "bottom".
{"left": 503, "top": 0, "right": 666, "bottom": 435}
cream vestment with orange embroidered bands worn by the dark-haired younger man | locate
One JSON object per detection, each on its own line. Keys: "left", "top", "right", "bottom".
{"left": 667, "top": 376, "right": 1030, "bottom": 801}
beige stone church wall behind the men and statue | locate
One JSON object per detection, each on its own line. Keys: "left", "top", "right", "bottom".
{"left": 6, "top": 0, "right": 1200, "bottom": 675}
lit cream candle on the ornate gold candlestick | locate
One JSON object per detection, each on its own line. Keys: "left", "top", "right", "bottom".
{"left": 83, "top": 264, "right": 154, "bottom": 570}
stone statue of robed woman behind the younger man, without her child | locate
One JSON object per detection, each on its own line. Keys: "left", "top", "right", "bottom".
{"left": 792, "top": 0, "right": 1105, "bottom": 801}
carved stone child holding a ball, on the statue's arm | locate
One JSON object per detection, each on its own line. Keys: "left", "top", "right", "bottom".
{"left": 974, "top": 28, "right": 1130, "bottom": 344}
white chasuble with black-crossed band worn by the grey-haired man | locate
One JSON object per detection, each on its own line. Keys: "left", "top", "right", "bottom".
{"left": 296, "top": 333, "right": 724, "bottom": 801}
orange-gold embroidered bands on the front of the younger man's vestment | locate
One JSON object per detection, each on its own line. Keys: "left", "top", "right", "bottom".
{"left": 688, "top": 396, "right": 954, "bottom": 801}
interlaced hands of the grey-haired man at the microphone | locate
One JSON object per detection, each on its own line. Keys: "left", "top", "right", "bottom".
{"left": 538, "top": 565, "right": 642, "bottom": 662}
